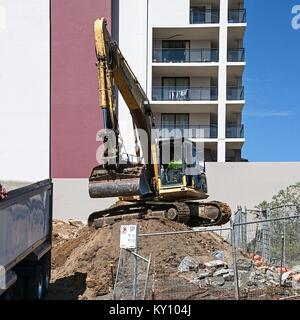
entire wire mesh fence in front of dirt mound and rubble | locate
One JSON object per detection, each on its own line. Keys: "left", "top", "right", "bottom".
{"left": 114, "top": 205, "right": 300, "bottom": 300}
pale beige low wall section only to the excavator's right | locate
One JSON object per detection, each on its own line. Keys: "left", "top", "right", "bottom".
{"left": 206, "top": 162, "right": 300, "bottom": 210}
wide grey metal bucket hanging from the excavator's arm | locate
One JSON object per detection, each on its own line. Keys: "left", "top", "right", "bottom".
{"left": 89, "top": 166, "right": 151, "bottom": 198}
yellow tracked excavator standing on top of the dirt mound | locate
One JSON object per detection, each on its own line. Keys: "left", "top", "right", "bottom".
{"left": 88, "top": 18, "right": 231, "bottom": 228}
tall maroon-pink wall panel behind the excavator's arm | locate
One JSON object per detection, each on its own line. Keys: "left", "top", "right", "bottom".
{"left": 51, "top": 0, "right": 112, "bottom": 178}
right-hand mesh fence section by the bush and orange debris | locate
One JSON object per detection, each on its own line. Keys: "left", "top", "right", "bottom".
{"left": 232, "top": 205, "right": 300, "bottom": 297}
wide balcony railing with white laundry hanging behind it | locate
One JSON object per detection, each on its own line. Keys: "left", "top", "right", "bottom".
{"left": 152, "top": 86, "right": 218, "bottom": 101}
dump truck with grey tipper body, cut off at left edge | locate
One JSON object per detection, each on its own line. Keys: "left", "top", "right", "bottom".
{"left": 0, "top": 180, "right": 53, "bottom": 300}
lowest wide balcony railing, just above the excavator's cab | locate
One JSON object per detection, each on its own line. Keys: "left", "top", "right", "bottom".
{"left": 155, "top": 124, "right": 218, "bottom": 139}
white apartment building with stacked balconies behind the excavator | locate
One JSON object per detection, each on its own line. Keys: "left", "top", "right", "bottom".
{"left": 114, "top": 0, "right": 247, "bottom": 162}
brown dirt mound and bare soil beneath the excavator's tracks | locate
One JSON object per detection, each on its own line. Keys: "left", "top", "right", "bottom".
{"left": 46, "top": 220, "right": 298, "bottom": 300}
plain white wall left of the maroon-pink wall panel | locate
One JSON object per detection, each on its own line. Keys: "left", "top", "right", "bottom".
{"left": 0, "top": 0, "right": 50, "bottom": 181}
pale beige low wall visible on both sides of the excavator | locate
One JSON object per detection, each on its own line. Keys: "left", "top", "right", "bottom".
{"left": 50, "top": 162, "right": 300, "bottom": 222}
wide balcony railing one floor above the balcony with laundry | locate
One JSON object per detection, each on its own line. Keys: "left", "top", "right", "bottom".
{"left": 153, "top": 48, "right": 219, "bottom": 63}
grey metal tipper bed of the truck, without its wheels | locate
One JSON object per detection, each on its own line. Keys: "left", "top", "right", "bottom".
{"left": 0, "top": 180, "right": 52, "bottom": 270}
